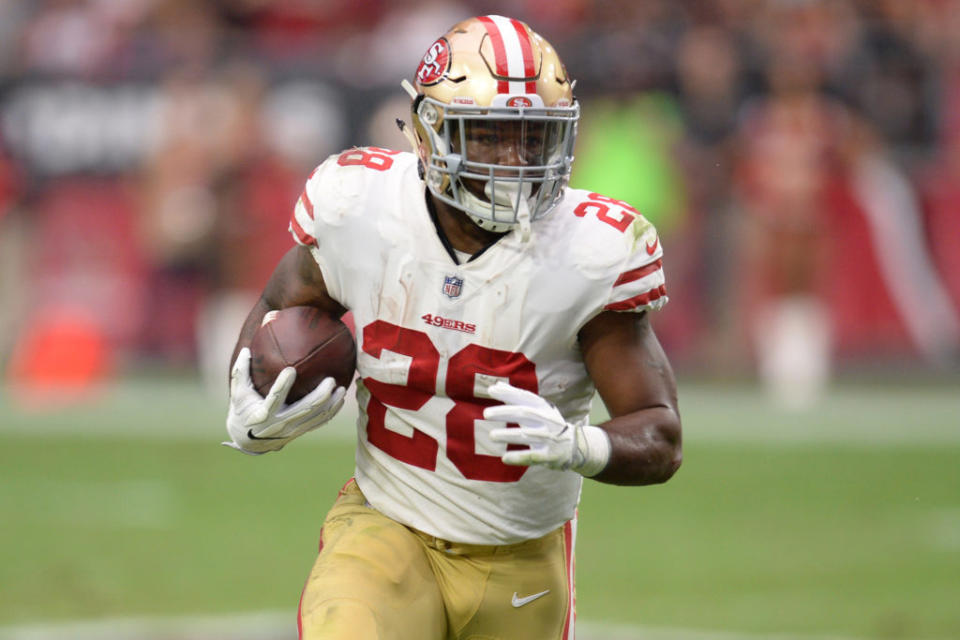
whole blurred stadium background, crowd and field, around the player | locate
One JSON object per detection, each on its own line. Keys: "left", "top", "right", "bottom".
{"left": 0, "top": 0, "right": 960, "bottom": 640}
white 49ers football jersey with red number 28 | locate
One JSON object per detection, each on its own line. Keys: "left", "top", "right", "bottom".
{"left": 290, "top": 147, "right": 667, "bottom": 544}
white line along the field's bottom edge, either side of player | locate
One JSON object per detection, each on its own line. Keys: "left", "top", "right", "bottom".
{"left": 0, "top": 611, "right": 916, "bottom": 640}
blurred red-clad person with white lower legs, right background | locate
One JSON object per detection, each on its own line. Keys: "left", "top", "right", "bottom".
{"left": 734, "top": 41, "right": 845, "bottom": 408}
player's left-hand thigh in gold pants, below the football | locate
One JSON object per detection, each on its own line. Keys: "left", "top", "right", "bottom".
{"left": 299, "top": 483, "right": 446, "bottom": 640}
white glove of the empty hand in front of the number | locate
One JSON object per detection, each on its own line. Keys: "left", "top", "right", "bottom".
{"left": 483, "top": 381, "right": 610, "bottom": 476}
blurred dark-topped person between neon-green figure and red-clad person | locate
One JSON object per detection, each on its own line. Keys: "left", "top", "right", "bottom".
{"left": 672, "top": 24, "right": 747, "bottom": 372}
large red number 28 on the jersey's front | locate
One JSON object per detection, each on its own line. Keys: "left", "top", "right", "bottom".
{"left": 363, "top": 320, "right": 538, "bottom": 482}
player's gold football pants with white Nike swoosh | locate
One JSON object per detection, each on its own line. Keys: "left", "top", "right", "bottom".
{"left": 298, "top": 480, "right": 575, "bottom": 640}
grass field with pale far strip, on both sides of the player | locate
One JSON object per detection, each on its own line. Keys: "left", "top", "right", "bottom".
{"left": 0, "top": 381, "right": 960, "bottom": 640}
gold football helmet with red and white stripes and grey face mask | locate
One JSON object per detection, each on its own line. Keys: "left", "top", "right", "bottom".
{"left": 403, "top": 15, "right": 580, "bottom": 235}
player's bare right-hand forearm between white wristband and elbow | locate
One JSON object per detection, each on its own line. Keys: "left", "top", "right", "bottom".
{"left": 593, "top": 407, "right": 683, "bottom": 485}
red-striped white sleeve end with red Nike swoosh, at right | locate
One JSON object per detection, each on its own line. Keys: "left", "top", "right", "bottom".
{"left": 603, "top": 217, "right": 668, "bottom": 312}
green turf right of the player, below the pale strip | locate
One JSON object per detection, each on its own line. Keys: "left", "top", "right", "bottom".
{"left": 578, "top": 445, "right": 960, "bottom": 638}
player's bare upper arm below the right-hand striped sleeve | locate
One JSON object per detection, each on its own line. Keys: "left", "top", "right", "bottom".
{"left": 579, "top": 311, "right": 677, "bottom": 418}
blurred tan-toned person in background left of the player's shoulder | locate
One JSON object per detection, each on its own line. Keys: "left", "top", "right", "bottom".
{"left": 140, "top": 65, "right": 260, "bottom": 364}
